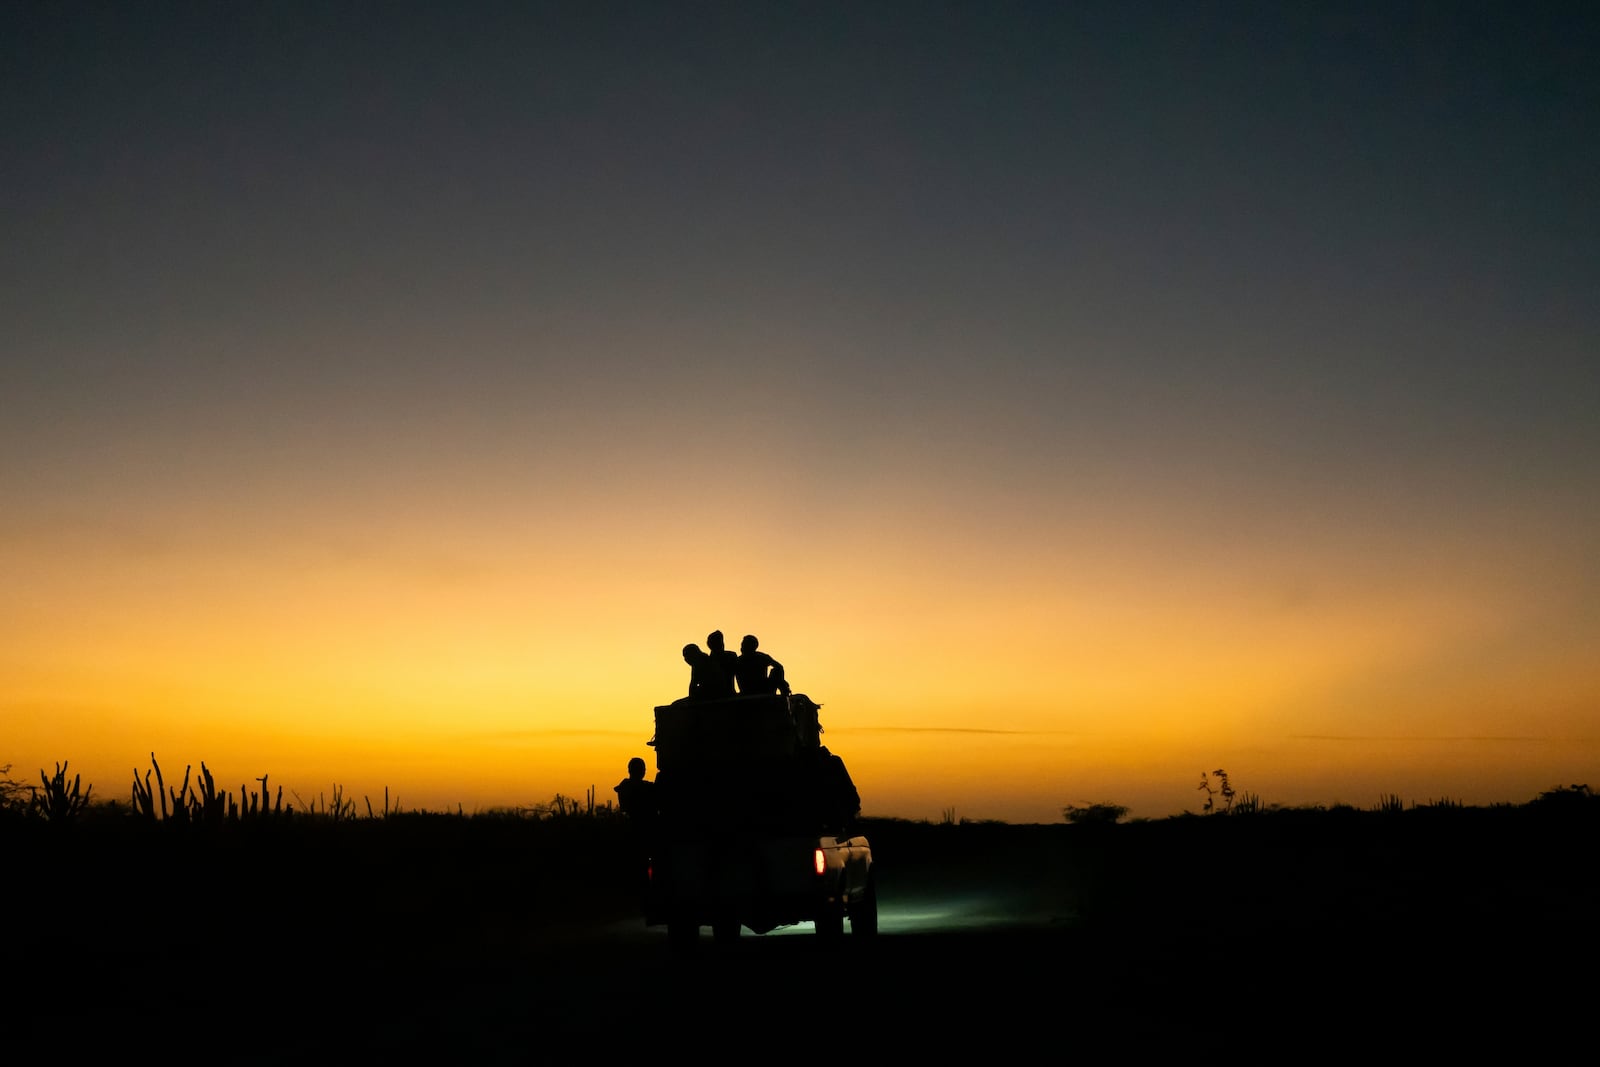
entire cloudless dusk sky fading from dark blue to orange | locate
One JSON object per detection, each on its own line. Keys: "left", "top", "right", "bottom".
{"left": 0, "top": 2, "right": 1600, "bottom": 822}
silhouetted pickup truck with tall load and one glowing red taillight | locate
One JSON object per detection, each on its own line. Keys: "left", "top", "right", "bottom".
{"left": 645, "top": 694, "right": 878, "bottom": 950}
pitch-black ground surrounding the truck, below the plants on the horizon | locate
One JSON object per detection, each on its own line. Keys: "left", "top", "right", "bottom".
{"left": 6, "top": 811, "right": 1600, "bottom": 1064}
